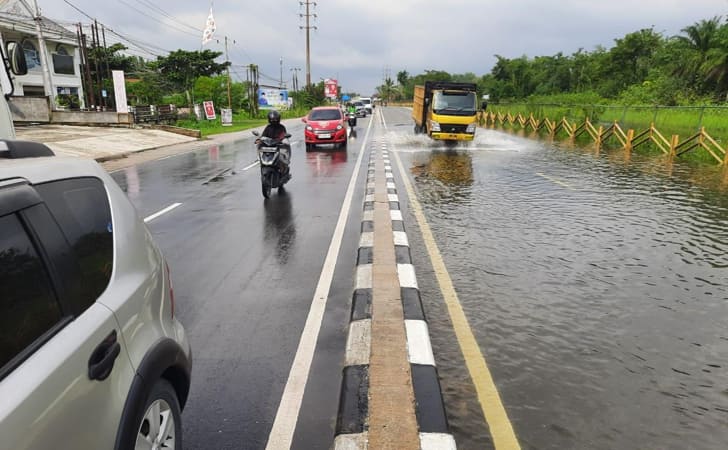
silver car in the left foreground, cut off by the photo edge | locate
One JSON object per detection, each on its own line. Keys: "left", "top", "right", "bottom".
{"left": 0, "top": 141, "right": 192, "bottom": 449}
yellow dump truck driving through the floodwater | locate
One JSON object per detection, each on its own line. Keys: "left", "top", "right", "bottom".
{"left": 412, "top": 81, "right": 477, "bottom": 141}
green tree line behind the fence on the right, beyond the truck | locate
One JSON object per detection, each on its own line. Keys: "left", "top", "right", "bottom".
{"left": 377, "top": 16, "right": 728, "bottom": 106}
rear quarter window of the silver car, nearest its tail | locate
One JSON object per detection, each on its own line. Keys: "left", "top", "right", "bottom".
{"left": 36, "top": 178, "right": 114, "bottom": 310}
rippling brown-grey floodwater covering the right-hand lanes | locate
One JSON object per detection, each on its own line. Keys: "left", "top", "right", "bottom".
{"left": 391, "top": 130, "right": 728, "bottom": 449}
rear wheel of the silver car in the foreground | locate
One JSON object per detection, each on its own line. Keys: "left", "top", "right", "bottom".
{"left": 134, "top": 379, "right": 182, "bottom": 450}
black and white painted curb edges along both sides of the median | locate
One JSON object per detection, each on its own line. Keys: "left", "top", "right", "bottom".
{"left": 334, "top": 141, "right": 456, "bottom": 450}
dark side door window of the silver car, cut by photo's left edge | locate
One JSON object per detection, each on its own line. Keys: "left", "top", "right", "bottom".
{"left": 0, "top": 214, "right": 62, "bottom": 378}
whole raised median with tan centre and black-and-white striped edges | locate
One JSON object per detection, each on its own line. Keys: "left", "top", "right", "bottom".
{"left": 334, "top": 142, "right": 456, "bottom": 450}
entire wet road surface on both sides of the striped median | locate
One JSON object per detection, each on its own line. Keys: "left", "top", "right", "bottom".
{"left": 109, "top": 108, "right": 728, "bottom": 450}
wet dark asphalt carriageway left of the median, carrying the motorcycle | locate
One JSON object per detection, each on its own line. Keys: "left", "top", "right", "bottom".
{"left": 113, "top": 119, "right": 369, "bottom": 450}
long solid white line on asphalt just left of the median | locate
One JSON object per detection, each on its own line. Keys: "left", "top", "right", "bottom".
{"left": 265, "top": 104, "right": 373, "bottom": 450}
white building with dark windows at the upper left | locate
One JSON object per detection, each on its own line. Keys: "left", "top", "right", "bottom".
{"left": 0, "top": 0, "right": 84, "bottom": 109}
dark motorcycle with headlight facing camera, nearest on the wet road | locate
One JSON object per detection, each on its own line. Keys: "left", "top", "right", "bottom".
{"left": 253, "top": 131, "right": 291, "bottom": 198}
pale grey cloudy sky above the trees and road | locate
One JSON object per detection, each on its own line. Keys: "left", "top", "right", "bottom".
{"left": 37, "top": 0, "right": 728, "bottom": 95}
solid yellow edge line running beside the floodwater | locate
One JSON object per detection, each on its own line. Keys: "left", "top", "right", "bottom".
{"left": 392, "top": 147, "right": 521, "bottom": 450}
